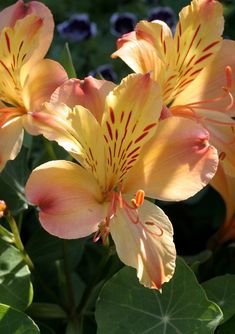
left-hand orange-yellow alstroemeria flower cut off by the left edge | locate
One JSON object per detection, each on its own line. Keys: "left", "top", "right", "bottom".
{"left": 0, "top": 0, "right": 67, "bottom": 170}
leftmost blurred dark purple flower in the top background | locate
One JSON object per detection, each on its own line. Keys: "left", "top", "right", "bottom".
{"left": 57, "top": 13, "right": 97, "bottom": 42}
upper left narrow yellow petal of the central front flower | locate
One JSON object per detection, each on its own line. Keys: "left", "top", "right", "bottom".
{"left": 30, "top": 103, "right": 106, "bottom": 188}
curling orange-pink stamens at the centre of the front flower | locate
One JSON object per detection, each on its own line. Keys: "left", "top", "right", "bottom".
{"left": 93, "top": 190, "right": 163, "bottom": 245}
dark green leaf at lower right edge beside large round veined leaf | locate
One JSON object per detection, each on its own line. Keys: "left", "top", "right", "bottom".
{"left": 202, "top": 274, "right": 235, "bottom": 322}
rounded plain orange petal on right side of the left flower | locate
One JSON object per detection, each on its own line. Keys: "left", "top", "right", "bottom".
{"left": 22, "top": 59, "right": 68, "bottom": 112}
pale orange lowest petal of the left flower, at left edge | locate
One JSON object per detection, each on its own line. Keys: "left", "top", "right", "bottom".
{"left": 0, "top": 117, "right": 24, "bottom": 170}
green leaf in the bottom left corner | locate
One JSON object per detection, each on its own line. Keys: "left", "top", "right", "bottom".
{"left": 0, "top": 304, "right": 40, "bottom": 334}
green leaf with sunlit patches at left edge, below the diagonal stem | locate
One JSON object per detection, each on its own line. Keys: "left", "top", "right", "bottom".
{"left": 0, "top": 239, "right": 33, "bottom": 310}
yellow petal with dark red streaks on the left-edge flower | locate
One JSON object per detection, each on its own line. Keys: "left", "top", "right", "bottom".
{"left": 0, "top": 15, "right": 42, "bottom": 106}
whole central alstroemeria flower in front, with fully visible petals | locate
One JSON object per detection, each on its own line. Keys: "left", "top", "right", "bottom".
{"left": 26, "top": 74, "right": 218, "bottom": 289}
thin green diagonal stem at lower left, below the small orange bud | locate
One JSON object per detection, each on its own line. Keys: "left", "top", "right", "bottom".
{"left": 6, "top": 211, "right": 35, "bottom": 271}
